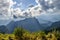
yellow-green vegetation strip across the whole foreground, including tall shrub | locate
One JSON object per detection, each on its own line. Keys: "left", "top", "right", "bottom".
{"left": 0, "top": 28, "right": 60, "bottom": 40}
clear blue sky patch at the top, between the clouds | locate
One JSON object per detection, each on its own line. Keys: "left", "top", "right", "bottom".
{"left": 13, "top": 0, "right": 37, "bottom": 10}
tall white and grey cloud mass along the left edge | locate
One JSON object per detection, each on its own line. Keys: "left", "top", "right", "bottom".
{"left": 0, "top": 0, "right": 16, "bottom": 19}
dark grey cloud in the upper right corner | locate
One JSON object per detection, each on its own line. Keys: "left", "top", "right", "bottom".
{"left": 36, "top": 0, "right": 60, "bottom": 11}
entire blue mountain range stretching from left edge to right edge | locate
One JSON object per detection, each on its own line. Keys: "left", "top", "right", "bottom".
{"left": 0, "top": 17, "right": 60, "bottom": 33}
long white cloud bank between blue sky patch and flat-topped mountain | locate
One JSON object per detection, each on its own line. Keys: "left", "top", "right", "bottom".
{"left": 12, "top": 5, "right": 42, "bottom": 18}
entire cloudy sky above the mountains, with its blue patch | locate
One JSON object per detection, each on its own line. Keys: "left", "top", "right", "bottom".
{"left": 0, "top": 0, "right": 60, "bottom": 24}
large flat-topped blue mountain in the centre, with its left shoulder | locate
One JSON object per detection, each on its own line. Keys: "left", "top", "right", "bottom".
{"left": 6, "top": 17, "right": 43, "bottom": 33}
